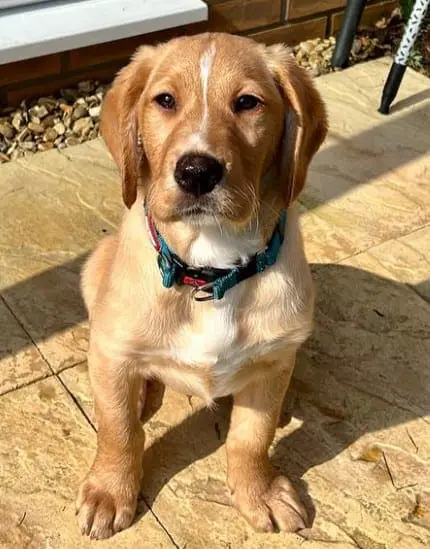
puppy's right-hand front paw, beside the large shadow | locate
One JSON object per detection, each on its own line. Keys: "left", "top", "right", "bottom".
{"left": 233, "top": 476, "right": 309, "bottom": 532}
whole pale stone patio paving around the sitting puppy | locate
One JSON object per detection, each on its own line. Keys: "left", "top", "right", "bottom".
{"left": 0, "top": 59, "right": 430, "bottom": 549}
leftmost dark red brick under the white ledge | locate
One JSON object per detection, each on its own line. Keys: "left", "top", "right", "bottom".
{"left": 0, "top": 53, "right": 61, "bottom": 86}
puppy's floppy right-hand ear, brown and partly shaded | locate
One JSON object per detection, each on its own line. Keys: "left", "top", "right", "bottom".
{"left": 266, "top": 44, "right": 328, "bottom": 207}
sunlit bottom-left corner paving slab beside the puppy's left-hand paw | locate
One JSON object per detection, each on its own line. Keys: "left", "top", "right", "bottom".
{"left": 0, "top": 378, "right": 174, "bottom": 549}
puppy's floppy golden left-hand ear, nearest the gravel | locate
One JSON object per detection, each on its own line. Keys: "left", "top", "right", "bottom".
{"left": 100, "top": 46, "right": 156, "bottom": 208}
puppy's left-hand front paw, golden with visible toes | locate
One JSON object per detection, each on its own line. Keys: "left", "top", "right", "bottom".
{"left": 76, "top": 473, "right": 137, "bottom": 539}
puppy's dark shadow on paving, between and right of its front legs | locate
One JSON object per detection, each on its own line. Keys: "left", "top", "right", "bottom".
{"left": 136, "top": 264, "right": 430, "bottom": 518}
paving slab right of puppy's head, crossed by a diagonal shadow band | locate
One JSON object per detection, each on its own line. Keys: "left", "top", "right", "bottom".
{"left": 300, "top": 58, "right": 430, "bottom": 261}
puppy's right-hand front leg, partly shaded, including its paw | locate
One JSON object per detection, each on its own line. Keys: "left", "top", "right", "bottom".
{"left": 226, "top": 352, "right": 308, "bottom": 532}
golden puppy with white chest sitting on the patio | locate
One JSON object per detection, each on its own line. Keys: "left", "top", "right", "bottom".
{"left": 77, "top": 34, "right": 327, "bottom": 538}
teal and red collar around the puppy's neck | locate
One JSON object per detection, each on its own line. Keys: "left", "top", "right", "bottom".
{"left": 145, "top": 210, "right": 287, "bottom": 301}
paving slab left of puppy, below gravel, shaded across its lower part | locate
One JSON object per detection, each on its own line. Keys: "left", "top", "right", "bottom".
{"left": 0, "top": 140, "right": 122, "bottom": 371}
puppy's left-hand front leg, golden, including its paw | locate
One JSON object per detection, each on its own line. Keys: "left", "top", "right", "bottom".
{"left": 76, "top": 345, "right": 144, "bottom": 539}
